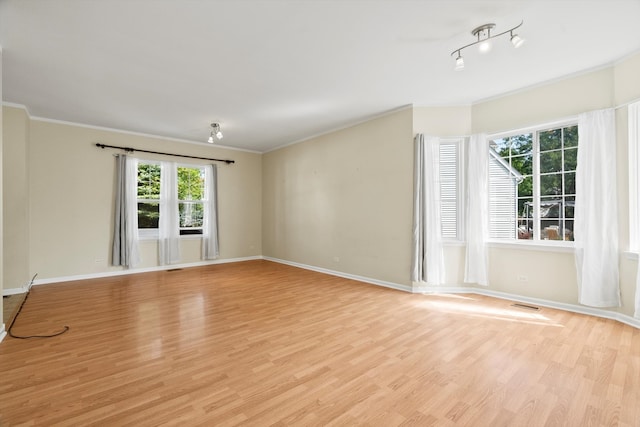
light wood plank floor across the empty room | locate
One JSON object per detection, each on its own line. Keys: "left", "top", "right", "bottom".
{"left": 0, "top": 261, "right": 640, "bottom": 427}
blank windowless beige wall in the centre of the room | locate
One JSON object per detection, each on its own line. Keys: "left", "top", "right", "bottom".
{"left": 263, "top": 108, "right": 413, "bottom": 286}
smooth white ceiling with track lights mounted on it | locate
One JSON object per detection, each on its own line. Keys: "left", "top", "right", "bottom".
{"left": 0, "top": 0, "right": 640, "bottom": 152}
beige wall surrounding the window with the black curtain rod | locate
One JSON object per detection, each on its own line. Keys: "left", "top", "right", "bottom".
{"left": 4, "top": 107, "right": 262, "bottom": 288}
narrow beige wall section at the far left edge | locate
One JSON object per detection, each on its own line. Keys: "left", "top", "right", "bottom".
{"left": 2, "top": 107, "right": 33, "bottom": 289}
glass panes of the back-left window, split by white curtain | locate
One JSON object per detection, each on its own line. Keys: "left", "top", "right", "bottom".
{"left": 138, "top": 162, "right": 204, "bottom": 237}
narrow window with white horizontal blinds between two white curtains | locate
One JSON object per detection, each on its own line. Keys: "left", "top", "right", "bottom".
{"left": 440, "top": 140, "right": 463, "bottom": 240}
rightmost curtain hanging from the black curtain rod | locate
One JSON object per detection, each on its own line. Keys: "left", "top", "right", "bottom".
{"left": 202, "top": 165, "right": 220, "bottom": 260}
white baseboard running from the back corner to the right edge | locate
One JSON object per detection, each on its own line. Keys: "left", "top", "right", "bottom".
{"left": 263, "top": 257, "right": 640, "bottom": 329}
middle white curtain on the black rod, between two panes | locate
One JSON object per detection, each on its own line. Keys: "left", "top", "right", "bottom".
{"left": 158, "top": 162, "right": 180, "bottom": 265}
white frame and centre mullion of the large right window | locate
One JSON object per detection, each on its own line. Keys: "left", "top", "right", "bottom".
{"left": 487, "top": 116, "right": 580, "bottom": 248}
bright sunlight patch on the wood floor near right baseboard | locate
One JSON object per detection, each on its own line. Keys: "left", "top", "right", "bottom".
{"left": 414, "top": 294, "right": 564, "bottom": 328}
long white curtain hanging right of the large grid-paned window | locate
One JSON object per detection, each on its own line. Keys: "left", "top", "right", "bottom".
{"left": 574, "top": 109, "right": 620, "bottom": 307}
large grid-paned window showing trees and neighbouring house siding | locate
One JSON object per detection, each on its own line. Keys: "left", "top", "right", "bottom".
{"left": 489, "top": 124, "right": 578, "bottom": 241}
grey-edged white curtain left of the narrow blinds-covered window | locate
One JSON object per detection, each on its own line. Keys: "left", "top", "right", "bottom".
{"left": 411, "top": 134, "right": 445, "bottom": 285}
